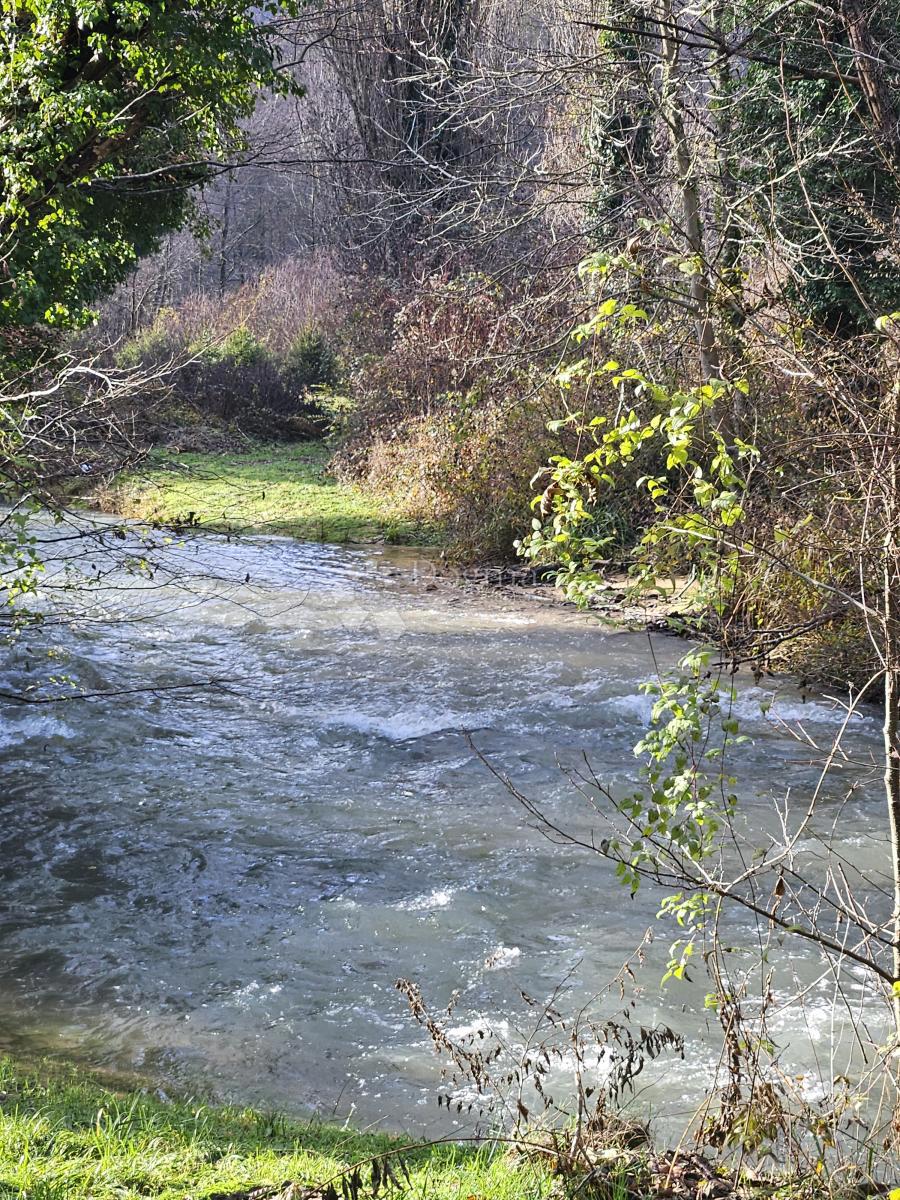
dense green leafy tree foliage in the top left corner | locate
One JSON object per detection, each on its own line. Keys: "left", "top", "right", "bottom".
{"left": 0, "top": 0, "right": 303, "bottom": 325}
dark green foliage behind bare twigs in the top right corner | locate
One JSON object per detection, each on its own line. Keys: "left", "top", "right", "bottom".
{"left": 724, "top": 0, "right": 900, "bottom": 335}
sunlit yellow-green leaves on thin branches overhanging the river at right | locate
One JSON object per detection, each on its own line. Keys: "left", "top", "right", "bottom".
{"left": 517, "top": 299, "right": 757, "bottom": 964}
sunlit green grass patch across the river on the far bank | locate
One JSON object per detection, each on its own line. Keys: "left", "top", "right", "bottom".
{"left": 97, "top": 442, "right": 436, "bottom": 545}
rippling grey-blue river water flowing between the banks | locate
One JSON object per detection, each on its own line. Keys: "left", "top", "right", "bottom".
{"left": 0, "top": 516, "right": 884, "bottom": 1132}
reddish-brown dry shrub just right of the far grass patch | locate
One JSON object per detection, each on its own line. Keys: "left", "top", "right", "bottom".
{"left": 334, "top": 271, "right": 652, "bottom": 562}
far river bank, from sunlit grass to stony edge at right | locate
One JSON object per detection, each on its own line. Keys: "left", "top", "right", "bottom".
{"left": 79, "top": 439, "right": 874, "bottom": 692}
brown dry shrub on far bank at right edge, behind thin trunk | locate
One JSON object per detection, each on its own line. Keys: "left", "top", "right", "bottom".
{"left": 714, "top": 335, "right": 883, "bottom": 689}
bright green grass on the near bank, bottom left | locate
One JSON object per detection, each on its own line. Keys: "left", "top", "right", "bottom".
{"left": 0, "top": 1060, "right": 551, "bottom": 1200}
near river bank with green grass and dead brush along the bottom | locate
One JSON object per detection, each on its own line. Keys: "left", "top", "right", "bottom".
{"left": 0, "top": 1057, "right": 883, "bottom": 1200}
